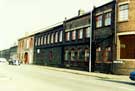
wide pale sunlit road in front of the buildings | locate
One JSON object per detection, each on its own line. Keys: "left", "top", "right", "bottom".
{"left": 0, "top": 63, "right": 135, "bottom": 91}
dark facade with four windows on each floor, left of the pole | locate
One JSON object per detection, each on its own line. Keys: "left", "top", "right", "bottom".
{"left": 63, "top": 13, "right": 91, "bottom": 70}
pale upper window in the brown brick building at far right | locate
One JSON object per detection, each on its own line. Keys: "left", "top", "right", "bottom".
{"left": 119, "top": 4, "right": 128, "bottom": 21}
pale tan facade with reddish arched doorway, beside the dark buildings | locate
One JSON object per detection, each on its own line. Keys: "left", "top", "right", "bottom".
{"left": 17, "top": 35, "right": 34, "bottom": 64}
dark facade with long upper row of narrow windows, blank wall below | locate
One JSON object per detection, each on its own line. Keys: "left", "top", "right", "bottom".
{"left": 34, "top": 23, "right": 63, "bottom": 66}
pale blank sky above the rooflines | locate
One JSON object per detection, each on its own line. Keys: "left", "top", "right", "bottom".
{"left": 0, "top": 0, "right": 112, "bottom": 50}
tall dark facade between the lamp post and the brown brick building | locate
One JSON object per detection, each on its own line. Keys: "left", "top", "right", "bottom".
{"left": 92, "top": 1, "right": 115, "bottom": 73}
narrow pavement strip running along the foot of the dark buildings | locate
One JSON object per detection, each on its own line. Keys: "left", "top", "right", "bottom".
{"left": 28, "top": 65, "right": 131, "bottom": 81}
